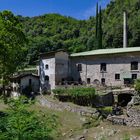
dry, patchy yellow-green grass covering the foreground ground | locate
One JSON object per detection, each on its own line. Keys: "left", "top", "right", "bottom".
{"left": 0, "top": 99, "right": 140, "bottom": 140}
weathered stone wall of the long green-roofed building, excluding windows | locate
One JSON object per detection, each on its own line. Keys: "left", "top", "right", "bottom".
{"left": 71, "top": 53, "right": 140, "bottom": 86}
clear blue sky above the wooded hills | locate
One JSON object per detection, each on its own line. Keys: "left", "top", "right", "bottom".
{"left": 0, "top": 0, "right": 110, "bottom": 19}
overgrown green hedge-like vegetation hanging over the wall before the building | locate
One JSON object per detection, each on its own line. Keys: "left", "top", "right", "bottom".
{"left": 53, "top": 87, "right": 97, "bottom": 105}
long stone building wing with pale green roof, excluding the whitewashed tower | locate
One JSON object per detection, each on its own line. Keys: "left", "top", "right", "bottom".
{"left": 70, "top": 47, "right": 140, "bottom": 86}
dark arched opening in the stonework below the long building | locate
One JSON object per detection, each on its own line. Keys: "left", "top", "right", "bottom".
{"left": 118, "top": 93, "right": 134, "bottom": 107}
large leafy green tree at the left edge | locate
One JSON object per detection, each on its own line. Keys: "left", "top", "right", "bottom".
{"left": 0, "top": 11, "right": 26, "bottom": 98}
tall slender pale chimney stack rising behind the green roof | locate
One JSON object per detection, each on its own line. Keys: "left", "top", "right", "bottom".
{"left": 123, "top": 11, "right": 127, "bottom": 48}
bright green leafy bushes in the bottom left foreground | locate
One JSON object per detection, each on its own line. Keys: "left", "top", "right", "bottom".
{"left": 0, "top": 97, "right": 57, "bottom": 140}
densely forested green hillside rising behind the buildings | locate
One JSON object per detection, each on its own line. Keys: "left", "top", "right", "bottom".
{"left": 19, "top": 0, "right": 140, "bottom": 64}
